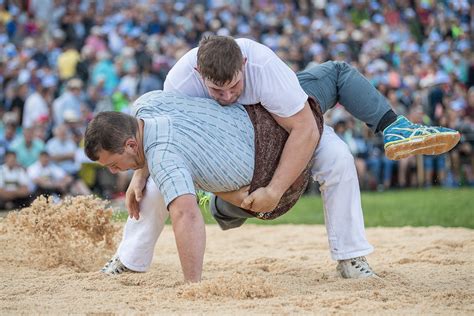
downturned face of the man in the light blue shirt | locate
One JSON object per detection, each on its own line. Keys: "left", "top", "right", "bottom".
{"left": 97, "top": 145, "right": 142, "bottom": 174}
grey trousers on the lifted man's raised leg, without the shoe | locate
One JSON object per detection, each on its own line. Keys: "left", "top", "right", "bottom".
{"left": 296, "top": 61, "right": 392, "bottom": 132}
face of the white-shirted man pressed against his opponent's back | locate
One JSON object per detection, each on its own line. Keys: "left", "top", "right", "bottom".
{"left": 204, "top": 70, "right": 244, "bottom": 105}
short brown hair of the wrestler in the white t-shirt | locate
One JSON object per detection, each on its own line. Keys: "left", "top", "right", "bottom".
{"left": 197, "top": 35, "right": 244, "bottom": 85}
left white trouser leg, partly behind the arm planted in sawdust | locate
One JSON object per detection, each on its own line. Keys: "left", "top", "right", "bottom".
{"left": 117, "top": 177, "right": 169, "bottom": 272}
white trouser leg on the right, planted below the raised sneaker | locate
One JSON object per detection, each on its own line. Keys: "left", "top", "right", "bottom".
{"left": 311, "top": 126, "right": 373, "bottom": 260}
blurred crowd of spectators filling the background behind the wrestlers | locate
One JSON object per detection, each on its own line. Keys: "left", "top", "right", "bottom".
{"left": 0, "top": 0, "right": 474, "bottom": 208}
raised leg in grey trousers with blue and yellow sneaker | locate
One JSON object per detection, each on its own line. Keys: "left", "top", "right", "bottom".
{"left": 297, "top": 61, "right": 461, "bottom": 160}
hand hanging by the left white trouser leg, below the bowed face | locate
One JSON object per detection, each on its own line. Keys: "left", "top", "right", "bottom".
{"left": 125, "top": 166, "right": 149, "bottom": 220}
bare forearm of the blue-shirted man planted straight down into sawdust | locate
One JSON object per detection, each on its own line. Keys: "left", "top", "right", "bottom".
{"left": 168, "top": 194, "right": 206, "bottom": 282}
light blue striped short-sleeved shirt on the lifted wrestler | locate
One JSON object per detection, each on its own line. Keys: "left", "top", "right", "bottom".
{"left": 134, "top": 91, "right": 255, "bottom": 205}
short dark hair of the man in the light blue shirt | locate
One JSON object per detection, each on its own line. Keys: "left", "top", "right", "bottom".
{"left": 84, "top": 111, "right": 138, "bottom": 161}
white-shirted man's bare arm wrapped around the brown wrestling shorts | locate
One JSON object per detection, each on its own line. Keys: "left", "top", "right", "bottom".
{"left": 241, "top": 102, "right": 320, "bottom": 212}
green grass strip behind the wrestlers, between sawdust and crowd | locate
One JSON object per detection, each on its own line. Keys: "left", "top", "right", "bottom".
{"left": 115, "top": 188, "right": 474, "bottom": 228}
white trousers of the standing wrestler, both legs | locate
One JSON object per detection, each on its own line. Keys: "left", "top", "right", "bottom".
{"left": 118, "top": 125, "right": 373, "bottom": 272}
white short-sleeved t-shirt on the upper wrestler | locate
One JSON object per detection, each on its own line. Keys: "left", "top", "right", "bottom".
{"left": 164, "top": 38, "right": 308, "bottom": 117}
